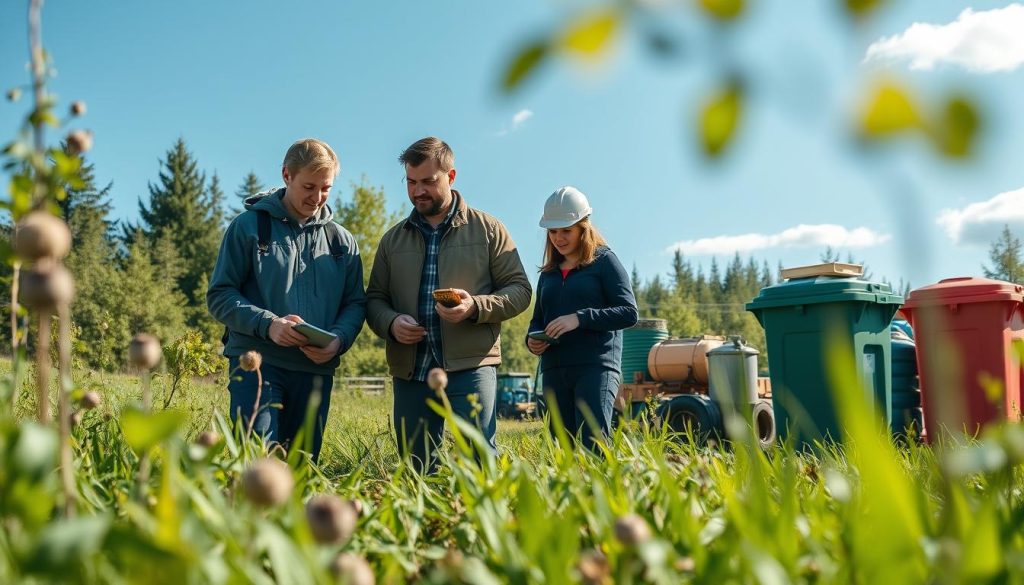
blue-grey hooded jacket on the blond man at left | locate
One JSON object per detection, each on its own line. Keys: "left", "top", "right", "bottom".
{"left": 206, "top": 189, "right": 367, "bottom": 374}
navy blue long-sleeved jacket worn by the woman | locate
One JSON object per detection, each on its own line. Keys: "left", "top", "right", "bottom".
{"left": 529, "top": 246, "right": 638, "bottom": 372}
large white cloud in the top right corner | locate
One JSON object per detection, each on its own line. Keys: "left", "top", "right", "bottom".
{"left": 864, "top": 3, "right": 1024, "bottom": 73}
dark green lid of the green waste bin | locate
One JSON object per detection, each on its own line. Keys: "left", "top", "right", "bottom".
{"left": 746, "top": 277, "right": 903, "bottom": 310}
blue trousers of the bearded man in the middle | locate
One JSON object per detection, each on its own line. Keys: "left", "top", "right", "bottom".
{"left": 393, "top": 366, "right": 498, "bottom": 472}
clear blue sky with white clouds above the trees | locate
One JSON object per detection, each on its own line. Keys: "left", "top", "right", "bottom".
{"left": 0, "top": 0, "right": 1024, "bottom": 286}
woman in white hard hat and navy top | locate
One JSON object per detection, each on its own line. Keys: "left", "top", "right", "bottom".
{"left": 526, "top": 186, "right": 638, "bottom": 447}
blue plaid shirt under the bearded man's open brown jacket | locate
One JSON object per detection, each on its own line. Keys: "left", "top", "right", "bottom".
{"left": 409, "top": 193, "right": 459, "bottom": 382}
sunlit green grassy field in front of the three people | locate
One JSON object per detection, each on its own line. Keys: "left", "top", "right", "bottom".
{"left": 0, "top": 354, "right": 1024, "bottom": 584}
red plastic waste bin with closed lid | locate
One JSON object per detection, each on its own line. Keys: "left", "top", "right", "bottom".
{"left": 902, "top": 277, "right": 1024, "bottom": 441}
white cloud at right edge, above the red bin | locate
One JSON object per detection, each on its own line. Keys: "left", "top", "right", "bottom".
{"left": 935, "top": 189, "right": 1024, "bottom": 244}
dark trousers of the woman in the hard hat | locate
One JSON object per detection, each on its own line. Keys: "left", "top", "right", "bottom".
{"left": 544, "top": 366, "right": 620, "bottom": 448}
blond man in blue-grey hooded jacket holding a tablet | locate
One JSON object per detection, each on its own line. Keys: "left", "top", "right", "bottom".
{"left": 206, "top": 138, "right": 367, "bottom": 461}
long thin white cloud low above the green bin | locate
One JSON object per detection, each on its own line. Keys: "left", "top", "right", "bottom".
{"left": 669, "top": 223, "right": 890, "bottom": 256}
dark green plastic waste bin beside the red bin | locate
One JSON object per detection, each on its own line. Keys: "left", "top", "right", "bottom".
{"left": 746, "top": 277, "right": 903, "bottom": 446}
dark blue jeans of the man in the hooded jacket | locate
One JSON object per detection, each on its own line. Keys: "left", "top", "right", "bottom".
{"left": 227, "top": 358, "right": 334, "bottom": 461}
